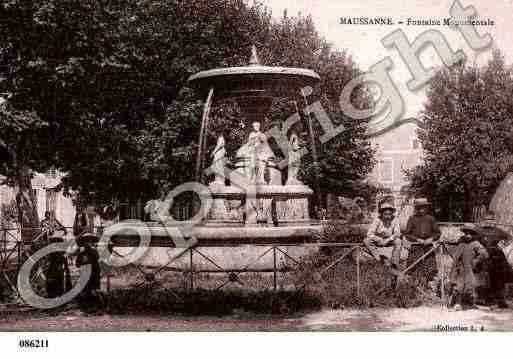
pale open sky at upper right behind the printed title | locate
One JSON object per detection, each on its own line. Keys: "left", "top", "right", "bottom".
{"left": 260, "top": 0, "right": 513, "bottom": 118}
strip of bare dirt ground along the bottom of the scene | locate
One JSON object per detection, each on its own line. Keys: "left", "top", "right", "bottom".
{"left": 0, "top": 306, "right": 513, "bottom": 331}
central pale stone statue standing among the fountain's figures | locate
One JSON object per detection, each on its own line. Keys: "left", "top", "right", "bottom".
{"left": 237, "top": 122, "right": 274, "bottom": 184}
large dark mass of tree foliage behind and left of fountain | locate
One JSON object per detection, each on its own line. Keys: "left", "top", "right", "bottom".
{"left": 0, "top": 0, "right": 372, "bottom": 228}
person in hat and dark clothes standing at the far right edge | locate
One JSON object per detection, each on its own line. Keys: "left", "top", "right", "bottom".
{"left": 479, "top": 212, "right": 513, "bottom": 308}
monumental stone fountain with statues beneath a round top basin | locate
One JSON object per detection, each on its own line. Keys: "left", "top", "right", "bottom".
{"left": 110, "top": 46, "right": 321, "bottom": 258}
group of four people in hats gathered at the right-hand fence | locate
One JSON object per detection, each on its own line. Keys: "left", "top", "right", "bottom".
{"left": 364, "top": 198, "right": 513, "bottom": 309}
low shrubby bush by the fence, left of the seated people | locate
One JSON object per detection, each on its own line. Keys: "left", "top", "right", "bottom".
{"left": 296, "top": 222, "right": 434, "bottom": 308}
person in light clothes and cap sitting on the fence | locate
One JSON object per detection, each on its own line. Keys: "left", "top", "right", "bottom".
{"left": 363, "top": 203, "right": 401, "bottom": 268}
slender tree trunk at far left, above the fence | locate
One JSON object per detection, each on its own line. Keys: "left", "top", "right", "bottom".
{"left": 16, "top": 166, "right": 41, "bottom": 243}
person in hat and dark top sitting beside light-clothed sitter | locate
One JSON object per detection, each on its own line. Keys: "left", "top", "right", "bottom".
{"left": 404, "top": 198, "right": 441, "bottom": 285}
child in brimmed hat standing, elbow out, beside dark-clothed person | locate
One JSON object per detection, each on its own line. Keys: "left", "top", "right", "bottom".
{"left": 450, "top": 225, "right": 488, "bottom": 310}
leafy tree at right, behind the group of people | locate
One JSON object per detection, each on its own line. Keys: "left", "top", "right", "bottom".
{"left": 409, "top": 51, "right": 513, "bottom": 221}
